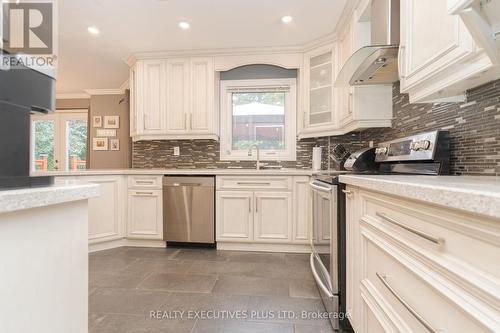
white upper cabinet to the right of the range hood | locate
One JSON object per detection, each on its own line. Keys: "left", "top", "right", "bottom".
{"left": 399, "top": 0, "right": 498, "bottom": 103}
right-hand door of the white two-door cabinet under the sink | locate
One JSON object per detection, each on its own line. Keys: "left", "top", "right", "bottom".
{"left": 254, "top": 192, "right": 292, "bottom": 242}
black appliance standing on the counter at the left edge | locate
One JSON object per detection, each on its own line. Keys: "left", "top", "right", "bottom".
{"left": 0, "top": 63, "right": 55, "bottom": 189}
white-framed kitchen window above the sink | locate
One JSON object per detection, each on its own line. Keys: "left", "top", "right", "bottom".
{"left": 220, "top": 79, "right": 297, "bottom": 161}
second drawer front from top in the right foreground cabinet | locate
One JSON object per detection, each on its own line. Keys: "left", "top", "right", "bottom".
{"left": 360, "top": 224, "right": 492, "bottom": 332}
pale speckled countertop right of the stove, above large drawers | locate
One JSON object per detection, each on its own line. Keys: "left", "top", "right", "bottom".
{"left": 340, "top": 175, "right": 500, "bottom": 218}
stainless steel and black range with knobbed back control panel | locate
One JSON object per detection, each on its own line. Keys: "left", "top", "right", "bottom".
{"left": 309, "top": 131, "right": 450, "bottom": 331}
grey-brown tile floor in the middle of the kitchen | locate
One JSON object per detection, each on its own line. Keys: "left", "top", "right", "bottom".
{"left": 89, "top": 248, "right": 338, "bottom": 333}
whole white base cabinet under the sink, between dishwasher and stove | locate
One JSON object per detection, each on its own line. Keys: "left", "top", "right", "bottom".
{"left": 216, "top": 176, "right": 311, "bottom": 250}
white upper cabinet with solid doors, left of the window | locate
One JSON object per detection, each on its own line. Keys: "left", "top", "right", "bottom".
{"left": 130, "top": 57, "right": 218, "bottom": 141}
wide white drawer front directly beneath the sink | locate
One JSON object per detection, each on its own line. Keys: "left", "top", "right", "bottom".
{"left": 217, "top": 176, "right": 292, "bottom": 191}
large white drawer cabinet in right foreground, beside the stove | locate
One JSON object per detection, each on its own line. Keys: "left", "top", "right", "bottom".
{"left": 346, "top": 186, "right": 500, "bottom": 333}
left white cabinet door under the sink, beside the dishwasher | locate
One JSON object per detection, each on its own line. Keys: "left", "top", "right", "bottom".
{"left": 216, "top": 191, "right": 253, "bottom": 242}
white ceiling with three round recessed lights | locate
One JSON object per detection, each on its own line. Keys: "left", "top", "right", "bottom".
{"left": 57, "top": 0, "right": 346, "bottom": 93}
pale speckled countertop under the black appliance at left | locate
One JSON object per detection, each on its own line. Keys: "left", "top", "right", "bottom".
{"left": 0, "top": 181, "right": 100, "bottom": 214}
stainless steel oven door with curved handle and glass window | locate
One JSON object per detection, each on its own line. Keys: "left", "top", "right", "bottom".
{"left": 309, "top": 180, "right": 338, "bottom": 329}
